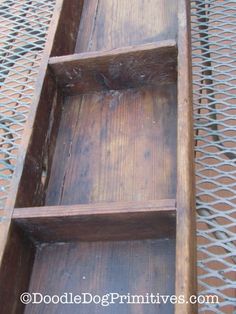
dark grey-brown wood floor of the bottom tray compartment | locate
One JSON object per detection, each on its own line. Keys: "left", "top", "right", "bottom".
{"left": 25, "top": 240, "right": 175, "bottom": 314}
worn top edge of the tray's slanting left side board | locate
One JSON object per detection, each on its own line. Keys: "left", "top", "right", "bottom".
{"left": 0, "top": 0, "right": 64, "bottom": 267}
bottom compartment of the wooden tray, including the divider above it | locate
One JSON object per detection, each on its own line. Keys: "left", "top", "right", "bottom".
{"left": 9, "top": 199, "right": 176, "bottom": 314}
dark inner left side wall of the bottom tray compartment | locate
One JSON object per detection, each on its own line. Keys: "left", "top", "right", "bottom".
{"left": 0, "top": 224, "right": 35, "bottom": 314}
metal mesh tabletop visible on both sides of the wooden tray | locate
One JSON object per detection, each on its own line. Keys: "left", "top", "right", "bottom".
{"left": 0, "top": 0, "right": 236, "bottom": 313}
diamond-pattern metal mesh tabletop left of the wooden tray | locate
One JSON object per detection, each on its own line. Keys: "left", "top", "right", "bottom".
{"left": 0, "top": 0, "right": 55, "bottom": 208}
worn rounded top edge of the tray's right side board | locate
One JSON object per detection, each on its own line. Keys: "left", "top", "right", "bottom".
{"left": 175, "top": 0, "right": 197, "bottom": 314}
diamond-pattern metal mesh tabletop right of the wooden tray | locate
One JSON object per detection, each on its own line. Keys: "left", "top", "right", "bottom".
{"left": 191, "top": 0, "right": 236, "bottom": 313}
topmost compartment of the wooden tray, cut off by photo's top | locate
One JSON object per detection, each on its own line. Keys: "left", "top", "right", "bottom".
{"left": 51, "top": 0, "right": 178, "bottom": 57}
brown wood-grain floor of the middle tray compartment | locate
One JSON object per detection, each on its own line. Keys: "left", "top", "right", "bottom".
{"left": 45, "top": 84, "right": 176, "bottom": 205}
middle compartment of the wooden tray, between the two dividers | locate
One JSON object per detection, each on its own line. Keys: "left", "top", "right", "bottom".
{"left": 15, "top": 51, "right": 177, "bottom": 207}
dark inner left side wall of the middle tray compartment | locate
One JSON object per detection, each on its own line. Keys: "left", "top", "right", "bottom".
{"left": 15, "top": 71, "right": 62, "bottom": 207}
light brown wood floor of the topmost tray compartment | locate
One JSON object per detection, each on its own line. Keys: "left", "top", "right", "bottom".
{"left": 75, "top": 0, "right": 178, "bottom": 53}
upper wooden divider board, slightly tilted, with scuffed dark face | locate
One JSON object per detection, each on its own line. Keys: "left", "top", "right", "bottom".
{"left": 49, "top": 40, "right": 177, "bottom": 94}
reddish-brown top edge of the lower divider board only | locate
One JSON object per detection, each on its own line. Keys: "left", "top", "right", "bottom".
{"left": 12, "top": 199, "right": 175, "bottom": 220}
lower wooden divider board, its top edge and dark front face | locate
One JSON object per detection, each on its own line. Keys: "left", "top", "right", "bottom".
{"left": 13, "top": 200, "right": 175, "bottom": 242}
